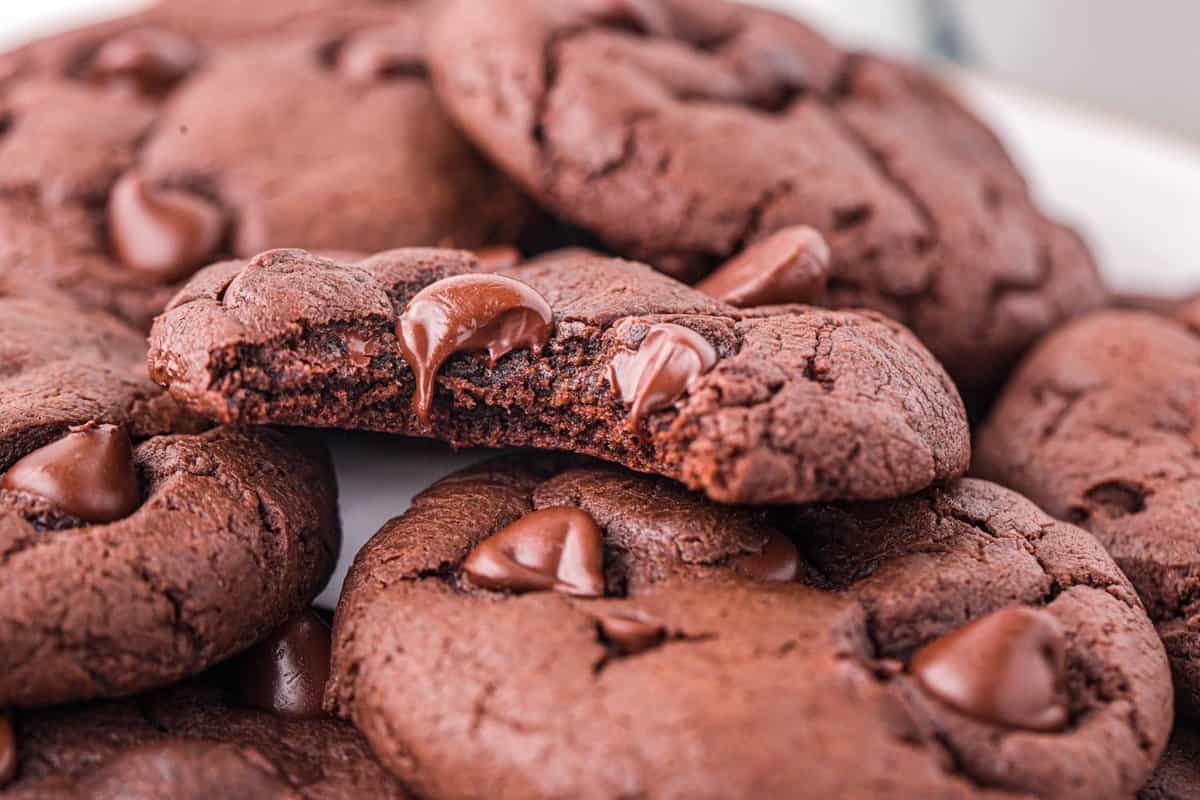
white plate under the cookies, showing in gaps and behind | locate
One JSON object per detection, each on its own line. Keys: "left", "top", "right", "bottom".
{"left": 0, "top": 0, "right": 1200, "bottom": 604}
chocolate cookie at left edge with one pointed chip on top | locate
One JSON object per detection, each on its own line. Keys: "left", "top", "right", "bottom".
{"left": 0, "top": 283, "right": 338, "bottom": 709}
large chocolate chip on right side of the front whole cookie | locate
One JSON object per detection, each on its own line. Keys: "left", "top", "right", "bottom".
{"left": 908, "top": 608, "right": 1067, "bottom": 730}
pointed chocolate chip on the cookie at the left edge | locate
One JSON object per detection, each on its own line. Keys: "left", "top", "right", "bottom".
{"left": 0, "top": 425, "right": 142, "bottom": 523}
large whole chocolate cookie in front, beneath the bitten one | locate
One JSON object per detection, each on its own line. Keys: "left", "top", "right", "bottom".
{"left": 326, "top": 458, "right": 1171, "bottom": 799}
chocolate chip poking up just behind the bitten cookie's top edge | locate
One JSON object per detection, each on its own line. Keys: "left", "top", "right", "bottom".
{"left": 696, "top": 225, "right": 830, "bottom": 308}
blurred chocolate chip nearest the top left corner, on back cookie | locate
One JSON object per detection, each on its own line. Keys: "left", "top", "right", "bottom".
{"left": 85, "top": 28, "right": 200, "bottom": 95}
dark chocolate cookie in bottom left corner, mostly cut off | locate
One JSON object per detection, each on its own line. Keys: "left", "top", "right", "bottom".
{"left": 0, "top": 609, "right": 408, "bottom": 800}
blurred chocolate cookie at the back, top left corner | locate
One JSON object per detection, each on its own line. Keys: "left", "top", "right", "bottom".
{"left": 0, "top": 2, "right": 528, "bottom": 325}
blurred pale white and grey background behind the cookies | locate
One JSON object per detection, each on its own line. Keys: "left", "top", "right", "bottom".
{"left": 0, "top": 0, "right": 1200, "bottom": 294}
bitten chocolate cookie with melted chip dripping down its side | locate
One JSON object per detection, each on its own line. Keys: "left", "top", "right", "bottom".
{"left": 150, "top": 249, "right": 970, "bottom": 504}
